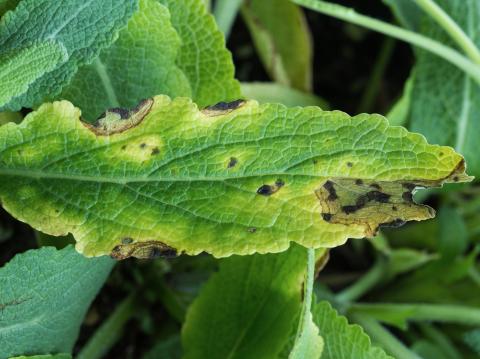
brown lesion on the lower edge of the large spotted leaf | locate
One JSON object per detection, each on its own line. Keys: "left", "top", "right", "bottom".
{"left": 110, "top": 237, "right": 177, "bottom": 260}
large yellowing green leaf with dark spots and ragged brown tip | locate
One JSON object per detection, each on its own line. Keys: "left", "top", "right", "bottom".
{"left": 0, "top": 96, "right": 469, "bottom": 259}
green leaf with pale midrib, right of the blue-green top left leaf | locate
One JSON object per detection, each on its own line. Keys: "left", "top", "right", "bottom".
{"left": 61, "top": 0, "right": 191, "bottom": 120}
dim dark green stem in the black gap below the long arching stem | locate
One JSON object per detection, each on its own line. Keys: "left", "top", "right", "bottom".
{"left": 354, "top": 37, "right": 395, "bottom": 113}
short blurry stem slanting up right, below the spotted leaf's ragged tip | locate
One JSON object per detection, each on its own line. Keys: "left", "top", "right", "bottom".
{"left": 336, "top": 257, "right": 386, "bottom": 303}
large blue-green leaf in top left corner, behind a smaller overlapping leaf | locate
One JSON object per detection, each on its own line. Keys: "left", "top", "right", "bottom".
{"left": 0, "top": 0, "right": 138, "bottom": 110}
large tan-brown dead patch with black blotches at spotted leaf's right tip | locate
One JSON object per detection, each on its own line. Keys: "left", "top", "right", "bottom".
{"left": 315, "top": 178, "right": 439, "bottom": 237}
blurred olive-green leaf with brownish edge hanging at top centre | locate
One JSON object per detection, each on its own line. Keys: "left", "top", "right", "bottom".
{"left": 242, "top": 0, "right": 313, "bottom": 92}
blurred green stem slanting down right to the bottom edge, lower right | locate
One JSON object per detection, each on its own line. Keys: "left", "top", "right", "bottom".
{"left": 350, "top": 313, "right": 422, "bottom": 359}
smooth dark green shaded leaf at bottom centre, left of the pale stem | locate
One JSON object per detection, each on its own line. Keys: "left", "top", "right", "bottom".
{"left": 182, "top": 245, "right": 307, "bottom": 359}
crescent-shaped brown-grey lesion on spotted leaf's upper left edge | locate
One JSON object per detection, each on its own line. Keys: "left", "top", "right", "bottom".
{"left": 82, "top": 98, "right": 154, "bottom": 136}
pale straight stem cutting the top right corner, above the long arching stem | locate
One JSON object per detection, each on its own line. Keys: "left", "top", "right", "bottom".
{"left": 415, "top": 0, "right": 480, "bottom": 64}
